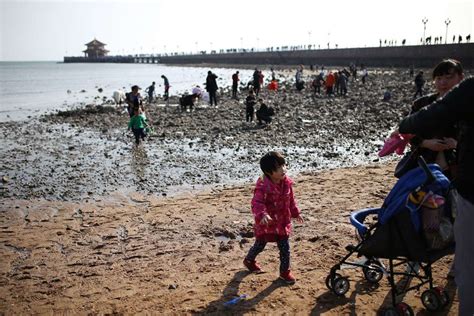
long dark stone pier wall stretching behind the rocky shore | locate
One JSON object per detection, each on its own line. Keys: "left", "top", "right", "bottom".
{"left": 64, "top": 43, "right": 474, "bottom": 68}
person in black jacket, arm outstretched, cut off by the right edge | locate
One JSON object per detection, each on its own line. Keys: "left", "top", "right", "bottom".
{"left": 398, "top": 77, "right": 474, "bottom": 316}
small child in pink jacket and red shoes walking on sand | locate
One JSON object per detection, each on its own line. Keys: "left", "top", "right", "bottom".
{"left": 244, "top": 151, "right": 303, "bottom": 284}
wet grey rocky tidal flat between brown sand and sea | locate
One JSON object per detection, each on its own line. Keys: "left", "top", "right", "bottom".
{"left": 0, "top": 69, "right": 426, "bottom": 200}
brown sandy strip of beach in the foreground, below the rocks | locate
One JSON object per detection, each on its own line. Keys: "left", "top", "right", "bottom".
{"left": 0, "top": 164, "right": 457, "bottom": 315}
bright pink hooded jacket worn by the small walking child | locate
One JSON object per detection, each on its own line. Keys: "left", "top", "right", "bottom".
{"left": 252, "top": 176, "right": 300, "bottom": 241}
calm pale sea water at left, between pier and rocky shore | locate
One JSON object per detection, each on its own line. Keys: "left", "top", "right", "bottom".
{"left": 0, "top": 62, "right": 252, "bottom": 121}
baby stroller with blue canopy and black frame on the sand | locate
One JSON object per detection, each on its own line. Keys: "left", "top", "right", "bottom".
{"left": 326, "top": 158, "right": 454, "bottom": 315}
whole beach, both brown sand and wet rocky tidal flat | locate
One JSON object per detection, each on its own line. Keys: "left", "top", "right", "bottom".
{"left": 0, "top": 69, "right": 466, "bottom": 315}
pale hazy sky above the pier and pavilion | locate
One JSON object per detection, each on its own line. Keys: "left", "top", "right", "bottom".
{"left": 0, "top": 0, "right": 474, "bottom": 61}
